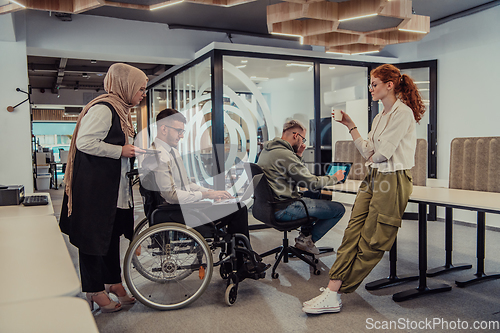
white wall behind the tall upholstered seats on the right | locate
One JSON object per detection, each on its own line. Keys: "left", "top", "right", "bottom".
{"left": 384, "top": 6, "right": 500, "bottom": 226}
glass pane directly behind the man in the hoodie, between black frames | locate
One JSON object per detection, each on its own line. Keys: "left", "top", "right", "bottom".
{"left": 223, "top": 56, "right": 314, "bottom": 191}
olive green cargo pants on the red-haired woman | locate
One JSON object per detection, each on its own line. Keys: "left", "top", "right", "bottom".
{"left": 330, "top": 168, "right": 413, "bottom": 293}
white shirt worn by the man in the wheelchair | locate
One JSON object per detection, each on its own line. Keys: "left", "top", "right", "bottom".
{"left": 140, "top": 138, "right": 209, "bottom": 204}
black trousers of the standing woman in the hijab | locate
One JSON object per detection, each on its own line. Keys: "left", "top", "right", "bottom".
{"left": 78, "top": 209, "right": 128, "bottom": 293}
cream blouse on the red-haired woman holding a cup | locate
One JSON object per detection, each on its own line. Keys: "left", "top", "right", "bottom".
{"left": 354, "top": 99, "right": 417, "bottom": 172}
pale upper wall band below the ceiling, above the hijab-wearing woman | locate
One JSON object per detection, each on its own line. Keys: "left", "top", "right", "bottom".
{"left": 27, "top": 10, "right": 311, "bottom": 64}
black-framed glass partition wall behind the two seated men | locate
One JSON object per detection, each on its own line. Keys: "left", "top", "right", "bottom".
{"left": 148, "top": 49, "right": 436, "bottom": 194}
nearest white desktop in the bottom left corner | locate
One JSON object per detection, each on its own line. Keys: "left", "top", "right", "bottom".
{"left": 0, "top": 297, "right": 99, "bottom": 333}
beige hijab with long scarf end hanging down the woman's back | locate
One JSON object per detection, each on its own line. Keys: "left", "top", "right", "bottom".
{"left": 64, "top": 63, "right": 148, "bottom": 216}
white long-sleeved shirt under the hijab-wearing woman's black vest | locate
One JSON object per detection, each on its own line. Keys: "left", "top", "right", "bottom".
{"left": 76, "top": 104, "right": 134, "bottom": 209}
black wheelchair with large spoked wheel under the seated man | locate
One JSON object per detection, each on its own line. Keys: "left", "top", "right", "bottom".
{"left": 123, "top": 170, "right": 269, "bottom": 310}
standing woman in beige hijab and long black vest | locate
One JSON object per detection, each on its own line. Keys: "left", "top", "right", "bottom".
{"left": 59, "top": 63, "right": 148, "bottom": 312}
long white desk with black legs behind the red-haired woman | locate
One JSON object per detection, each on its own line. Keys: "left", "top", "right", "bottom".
{"left": 325, "top": 180, "right": 500, "bottom": 301}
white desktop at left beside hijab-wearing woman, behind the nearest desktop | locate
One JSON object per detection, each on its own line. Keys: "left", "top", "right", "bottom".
{"left": 0, "top": 214, "right": 80, "bottom": 304}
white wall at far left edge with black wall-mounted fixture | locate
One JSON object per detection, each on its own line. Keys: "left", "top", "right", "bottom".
{"left": 0, "top": 14, "right": 33, "bottom": 193}
